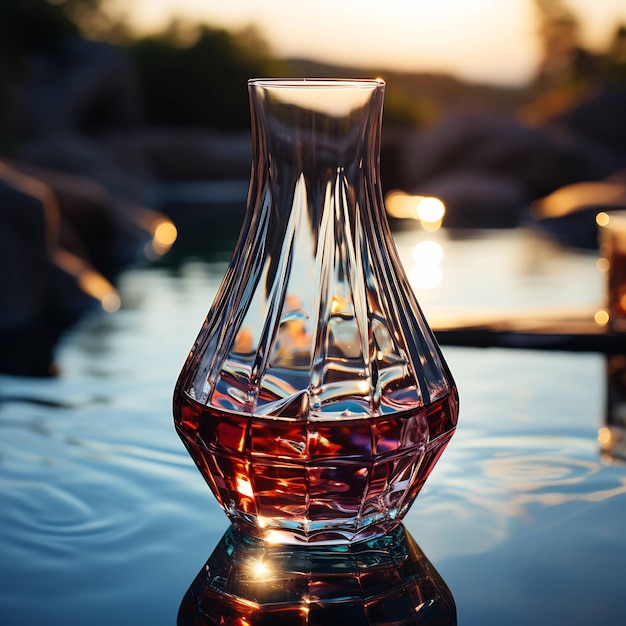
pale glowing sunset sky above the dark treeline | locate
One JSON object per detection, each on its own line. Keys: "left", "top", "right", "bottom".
{"left": 109, "top": 0, "right": 626, "bottom": 85}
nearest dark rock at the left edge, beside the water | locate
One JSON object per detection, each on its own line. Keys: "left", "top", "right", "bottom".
{"left": 0, "top": 163, "right": 97, "bottom": 376}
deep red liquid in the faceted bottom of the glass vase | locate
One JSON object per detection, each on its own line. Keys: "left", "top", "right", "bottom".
{"left": 175, "top": 390, "right": 458, "bottom": 542}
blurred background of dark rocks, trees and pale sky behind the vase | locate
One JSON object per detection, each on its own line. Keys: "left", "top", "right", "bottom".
{"left": 0, "top": 0, "right": 626, "bottom": 375}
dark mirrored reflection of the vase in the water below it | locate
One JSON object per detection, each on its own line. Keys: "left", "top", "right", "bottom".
{"left": 178, "top": 525, "right": 456, "bottom": 626}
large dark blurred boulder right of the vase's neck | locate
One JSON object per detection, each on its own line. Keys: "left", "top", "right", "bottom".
{"left": 406, "top": 114, "right": 618, "bottom": 226}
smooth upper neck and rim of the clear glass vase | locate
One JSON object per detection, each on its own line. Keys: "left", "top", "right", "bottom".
{"left": 249, "top": 80, "right": 385, "bottom": 200}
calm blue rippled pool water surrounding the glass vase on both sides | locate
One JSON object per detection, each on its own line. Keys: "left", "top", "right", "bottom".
{"left": 0, "top": 230, "right": 626, "bottom": 626}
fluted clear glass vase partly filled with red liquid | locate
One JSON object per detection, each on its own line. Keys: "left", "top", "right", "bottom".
{"left": 174, "top": 79, "right": 458, "bottom": 542}
